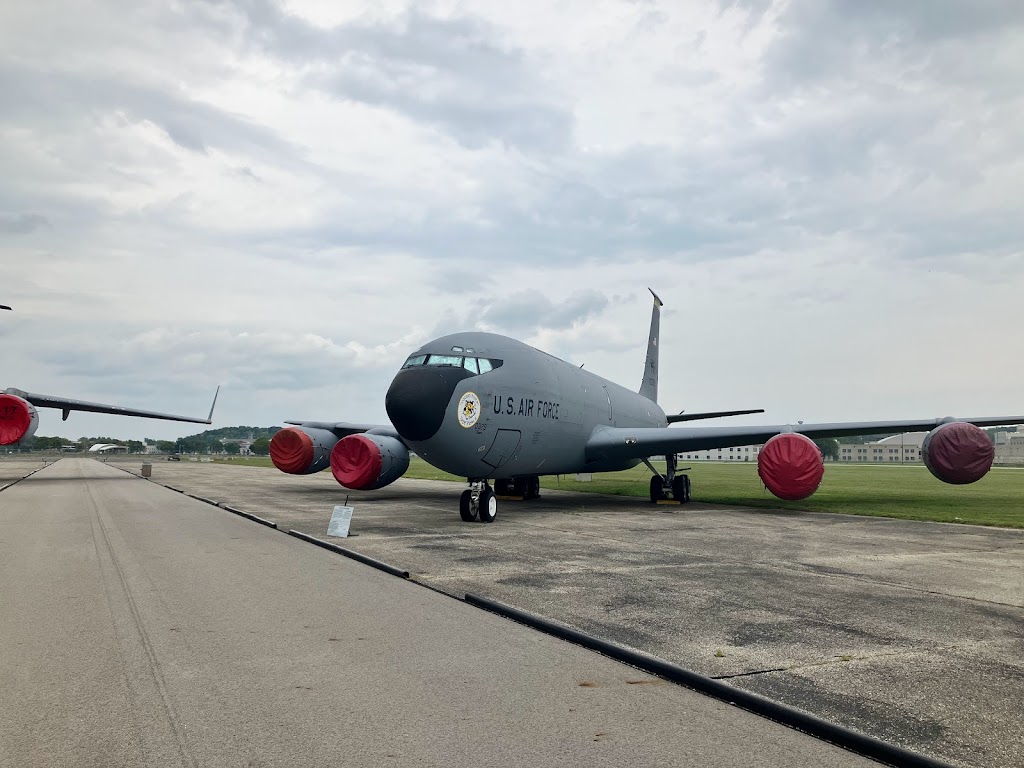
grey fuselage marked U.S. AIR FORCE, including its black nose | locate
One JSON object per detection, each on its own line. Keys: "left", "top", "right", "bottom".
{"left": 386, "top": 333, "right": 668, "bottom": 479}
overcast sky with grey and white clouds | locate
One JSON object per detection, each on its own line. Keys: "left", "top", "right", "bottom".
{"left": 0, "top": 0, "right": 1024, "bottom": 438}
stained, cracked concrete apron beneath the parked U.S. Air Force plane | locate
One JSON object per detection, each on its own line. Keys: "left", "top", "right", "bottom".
{"left": 105, "top": 458, "right": 1024, "bottom": 768}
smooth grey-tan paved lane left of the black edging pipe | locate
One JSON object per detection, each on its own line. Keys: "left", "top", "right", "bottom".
{"left": 0, "top": 459, "right": 872, "bottom": 768}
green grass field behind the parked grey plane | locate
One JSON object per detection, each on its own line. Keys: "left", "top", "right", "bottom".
{"left": 211, "top": 458, "right": 1024, "bottom": 528}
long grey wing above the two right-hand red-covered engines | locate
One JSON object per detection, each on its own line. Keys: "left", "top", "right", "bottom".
{"left": 587, "top": 416, "right": 1024, "bottom": 462}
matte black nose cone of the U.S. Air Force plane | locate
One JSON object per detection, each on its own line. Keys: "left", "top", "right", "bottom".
{"left": 384, "top": 366, "right": 472, "bottom": 442}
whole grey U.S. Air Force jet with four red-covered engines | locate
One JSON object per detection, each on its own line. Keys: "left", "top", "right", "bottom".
{"left": 270, "top": 291, "right": 1024, "bottom": 522}
